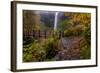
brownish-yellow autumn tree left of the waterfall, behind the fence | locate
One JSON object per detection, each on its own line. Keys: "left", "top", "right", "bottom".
{"left": 23, "top": 10, "right": 40, "bottom": 38}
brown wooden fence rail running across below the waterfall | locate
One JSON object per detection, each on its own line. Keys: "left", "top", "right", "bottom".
{"left": 23, "top": 30, "right": 64, "bottom": 38}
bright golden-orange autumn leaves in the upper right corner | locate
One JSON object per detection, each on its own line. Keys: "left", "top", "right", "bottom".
{"left": 64, "top": 12, "right": 91, "bottom": 26}
